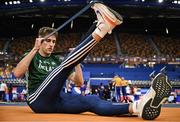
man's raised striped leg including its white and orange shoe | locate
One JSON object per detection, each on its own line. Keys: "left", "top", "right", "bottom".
{"left": 28, "top": 3, "right": 122, "bottom": 112}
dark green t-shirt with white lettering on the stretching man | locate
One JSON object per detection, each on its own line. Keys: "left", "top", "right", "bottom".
{"left": 28, "top": 53, "right": 61, "bottom": 94}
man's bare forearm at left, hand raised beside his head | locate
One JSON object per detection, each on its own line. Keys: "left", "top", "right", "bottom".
{"left": 14, "top": 38, "right": 42, "bottom": 78}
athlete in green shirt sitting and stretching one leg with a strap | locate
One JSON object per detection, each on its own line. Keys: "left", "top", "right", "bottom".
{"left": 14, "top": 3, "right": 171, "bottom": 119}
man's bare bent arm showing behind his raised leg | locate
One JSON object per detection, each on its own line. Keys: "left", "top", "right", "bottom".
{"left": 68, "top": 64, "right": 84, "bottom": 86}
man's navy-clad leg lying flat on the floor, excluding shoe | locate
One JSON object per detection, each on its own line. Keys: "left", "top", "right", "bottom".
{"left": 56, "top": 93, "right": 129, "bottom": 116}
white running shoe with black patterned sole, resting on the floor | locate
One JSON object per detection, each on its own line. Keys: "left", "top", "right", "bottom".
{"left": 136, "top": 73, "right": 172, "bottom": 120}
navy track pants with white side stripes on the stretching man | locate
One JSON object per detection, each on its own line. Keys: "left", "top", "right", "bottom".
{"left": 28, "top": 23, "right": 129, "bottom": 116}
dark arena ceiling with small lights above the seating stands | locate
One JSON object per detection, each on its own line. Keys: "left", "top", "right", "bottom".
{"left": 0, "top": 0, "right": 180, "bottom": 38}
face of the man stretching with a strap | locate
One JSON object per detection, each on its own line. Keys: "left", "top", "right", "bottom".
{"left": 40, "top": 35, "right": 56, "bottom": 55}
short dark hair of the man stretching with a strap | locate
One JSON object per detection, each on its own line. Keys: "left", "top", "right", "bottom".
{"left": 38, "top": 27, "right": 58, "bottom": 38}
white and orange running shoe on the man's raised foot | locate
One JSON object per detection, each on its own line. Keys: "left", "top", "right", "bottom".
{"left": 92, "top": 3, "right": 123, "bottom": 33}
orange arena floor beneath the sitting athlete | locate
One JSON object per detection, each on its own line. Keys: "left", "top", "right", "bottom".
{"left": 0, "top": 105, "right": 180, "bottom": 122}
